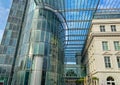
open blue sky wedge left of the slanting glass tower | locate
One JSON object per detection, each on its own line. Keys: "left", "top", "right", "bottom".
{"left": 0, "top": 0, "right": 12, "bottom": 41}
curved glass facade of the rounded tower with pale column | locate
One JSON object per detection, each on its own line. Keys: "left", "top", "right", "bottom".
{"left": 12, "top": 0, "right": 65, "bottom": 85}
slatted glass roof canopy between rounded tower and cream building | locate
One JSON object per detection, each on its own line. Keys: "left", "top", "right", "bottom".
{"left": 62, "top": 0, "right": 120, "bottom": 63}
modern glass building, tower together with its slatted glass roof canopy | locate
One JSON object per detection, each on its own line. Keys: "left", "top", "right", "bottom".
{"left": 0, "top": 0, "right": 120, "bottom": 85}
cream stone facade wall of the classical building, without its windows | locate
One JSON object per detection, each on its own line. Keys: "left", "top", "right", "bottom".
{"left": 84, "top": 19, "right": 120, "bottom": 85}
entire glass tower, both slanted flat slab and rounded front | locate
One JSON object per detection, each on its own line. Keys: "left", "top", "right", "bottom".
{"left": 0, "top": 0, "right": 65, "bottom": 85}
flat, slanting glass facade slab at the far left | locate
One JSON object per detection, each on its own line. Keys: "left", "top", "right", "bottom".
{"left": 0, "top": 0, "right": 26, "bottom": 85}
